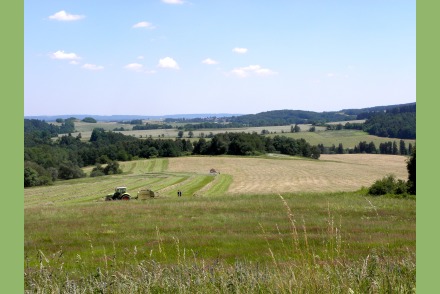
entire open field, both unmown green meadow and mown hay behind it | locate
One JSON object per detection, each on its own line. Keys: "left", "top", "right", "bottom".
{"left": 24, "top": 154, "right": 416, "bottom": 293}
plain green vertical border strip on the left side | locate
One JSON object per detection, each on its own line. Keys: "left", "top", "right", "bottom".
{"left": 0, "top": 1, "right": 24, "bottom": 293}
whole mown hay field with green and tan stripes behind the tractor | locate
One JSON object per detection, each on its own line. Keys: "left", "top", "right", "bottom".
{"left": 25, "top": 154, "right": 408, "bottom": 207}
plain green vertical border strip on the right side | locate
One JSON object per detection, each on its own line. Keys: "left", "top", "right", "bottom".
{"left": 416, "top": 0, "right": 440, "bottom": 293}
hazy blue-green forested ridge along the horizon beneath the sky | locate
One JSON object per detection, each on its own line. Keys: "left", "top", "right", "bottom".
{"left": 25, "top": 102, "right": 416, "bottom": 126}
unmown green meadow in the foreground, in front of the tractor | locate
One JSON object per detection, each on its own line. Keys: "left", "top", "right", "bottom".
{"left": 24, "top": 192, "right": 416, "bottom": 293}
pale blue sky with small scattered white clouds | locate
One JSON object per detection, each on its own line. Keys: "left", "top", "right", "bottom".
{"left": 24, "top": 0, "right": 416, "bottom": 116}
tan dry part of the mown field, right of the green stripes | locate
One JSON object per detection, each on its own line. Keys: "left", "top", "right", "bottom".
{"left": 168, "top": 154, "right": 408, "bottom": 194}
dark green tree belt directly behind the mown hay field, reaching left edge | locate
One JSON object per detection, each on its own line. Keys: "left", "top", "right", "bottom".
{"left": 24, "top": 126, "right": 319, "bottom": 187}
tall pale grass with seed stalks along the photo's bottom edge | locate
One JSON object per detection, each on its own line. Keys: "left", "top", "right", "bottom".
{"left": 24, "top": 196, "right": 416, "bottom": 293}
